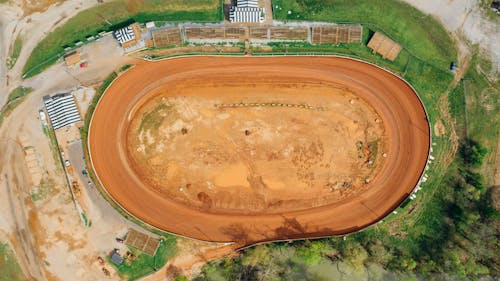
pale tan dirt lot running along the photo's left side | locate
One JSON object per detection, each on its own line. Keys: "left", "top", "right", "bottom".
{"left": 0, "top": 15, "right": 133, "bottom": 280}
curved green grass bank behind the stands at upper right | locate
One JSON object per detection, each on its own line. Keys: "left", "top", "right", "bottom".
{"left": 272, "top": 0, "right": 457, "bottom": 68}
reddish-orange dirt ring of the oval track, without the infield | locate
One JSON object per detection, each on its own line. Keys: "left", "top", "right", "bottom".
{"left": 88, "top": 57, "right": 430, "bottom": 246}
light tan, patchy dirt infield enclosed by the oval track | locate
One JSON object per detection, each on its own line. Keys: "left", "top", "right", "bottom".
{"left": 127, "top": 75, "right": 386, "bottom": 214}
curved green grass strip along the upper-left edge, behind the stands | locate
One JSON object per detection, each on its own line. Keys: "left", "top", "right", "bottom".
{"left": 23, "top": 0, "right": 223, "bottom": 78}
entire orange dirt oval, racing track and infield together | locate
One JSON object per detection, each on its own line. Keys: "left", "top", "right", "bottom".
{"left": 89, "top": 57, "right": 429, "bottom": 246}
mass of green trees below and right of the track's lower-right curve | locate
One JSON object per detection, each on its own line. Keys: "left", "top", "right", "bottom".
{"left": 196, "top": 140, "right": 500, "bottom": 281}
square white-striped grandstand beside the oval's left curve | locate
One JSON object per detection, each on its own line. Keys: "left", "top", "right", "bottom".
{"left": 43, "top": 94, "right": 81, "bottom": 130}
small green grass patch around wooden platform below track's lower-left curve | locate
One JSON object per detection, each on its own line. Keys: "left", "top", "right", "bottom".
{"left": 112, "top": 236, "right": 176, "bottom": 280}
